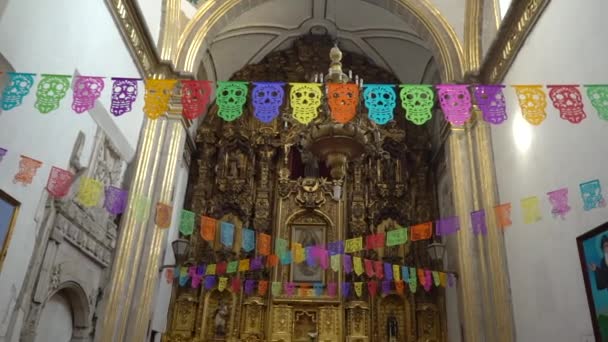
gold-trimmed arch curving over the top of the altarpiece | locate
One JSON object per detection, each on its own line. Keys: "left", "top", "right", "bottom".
{"left": 173, "top": 0, "right": 464, "bottom": 82}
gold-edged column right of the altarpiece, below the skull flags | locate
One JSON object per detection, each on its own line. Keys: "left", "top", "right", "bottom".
{"left": 446, "top": 116, "right": 514, "bottom": 342}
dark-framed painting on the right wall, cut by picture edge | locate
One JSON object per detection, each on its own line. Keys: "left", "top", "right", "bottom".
{"left": 576, "top": 222, "right": 608, "bottom": 341}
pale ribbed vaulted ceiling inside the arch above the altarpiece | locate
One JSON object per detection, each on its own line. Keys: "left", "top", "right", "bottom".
{"left": 203, "top": 0, "right": 438, "bottom": 83}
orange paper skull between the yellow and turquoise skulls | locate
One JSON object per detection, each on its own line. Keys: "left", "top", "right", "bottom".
{"left": 328, "top": 83, "right": 359, "bottom": 123}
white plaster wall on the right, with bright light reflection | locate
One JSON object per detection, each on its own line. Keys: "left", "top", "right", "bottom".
{"left": 492, "top": 0, "right": 608, "bottom": 342}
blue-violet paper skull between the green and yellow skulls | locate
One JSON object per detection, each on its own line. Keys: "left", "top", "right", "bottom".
{"left": 251, "top": 82, "right": 285, "bottom": 123}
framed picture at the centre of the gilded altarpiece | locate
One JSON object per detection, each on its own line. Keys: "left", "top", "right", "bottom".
{"left": 291, "top": 224, "right": 326, "bottom": 283}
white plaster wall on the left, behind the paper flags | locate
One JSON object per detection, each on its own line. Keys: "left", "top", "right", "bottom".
{"left": 0, "top": 0, "right": 143, "bottom": 341}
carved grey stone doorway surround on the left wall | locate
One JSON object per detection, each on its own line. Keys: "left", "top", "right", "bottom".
{"left": 13, "top": 129, "right": 126, "bottom": 342}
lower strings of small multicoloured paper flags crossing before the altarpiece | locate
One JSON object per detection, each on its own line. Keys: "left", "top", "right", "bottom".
{"left": 0, "top": 149, "right": 606, "bottom": 296}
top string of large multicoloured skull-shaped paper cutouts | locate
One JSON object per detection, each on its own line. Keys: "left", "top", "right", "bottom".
{"left": 2, "top": 72, "right": 608, "bottom": 126}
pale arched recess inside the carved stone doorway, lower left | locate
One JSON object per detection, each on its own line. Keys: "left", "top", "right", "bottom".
{"left": 35, "top": 293, "right": 74, "bottom": 342}
